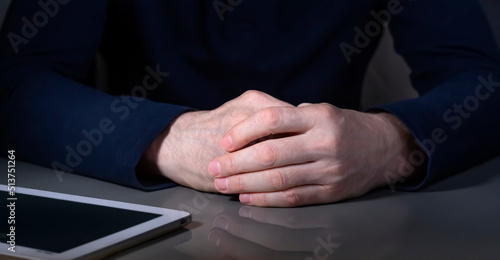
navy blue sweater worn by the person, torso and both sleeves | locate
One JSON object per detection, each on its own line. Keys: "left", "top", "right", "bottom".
{"left": 0, "top": 0, "right": 500, "bottom": 190}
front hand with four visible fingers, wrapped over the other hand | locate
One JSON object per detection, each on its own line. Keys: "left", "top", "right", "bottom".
{"left": 209, "top": 104, "right": 422, "bottom": 207}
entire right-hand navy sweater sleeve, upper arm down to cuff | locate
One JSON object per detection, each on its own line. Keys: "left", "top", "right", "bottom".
{"left": 374, "top": 0, "right": 500, "bottom": 190}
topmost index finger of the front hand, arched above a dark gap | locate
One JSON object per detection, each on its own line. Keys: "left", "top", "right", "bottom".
{"left": 221, "top": 106, "right": 313, "bottom": 152}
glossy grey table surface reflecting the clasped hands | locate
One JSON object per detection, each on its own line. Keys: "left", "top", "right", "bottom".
{"left": 0, "top": 158, "right": 500, "bottom": 259}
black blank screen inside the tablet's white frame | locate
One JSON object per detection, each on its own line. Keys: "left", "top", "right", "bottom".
{"left": 0, "top": 191, "right": 161, "bottom": 253}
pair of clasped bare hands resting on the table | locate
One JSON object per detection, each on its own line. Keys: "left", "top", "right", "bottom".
{"left": 141, "top": 91, "right": 419, "bottom": 207}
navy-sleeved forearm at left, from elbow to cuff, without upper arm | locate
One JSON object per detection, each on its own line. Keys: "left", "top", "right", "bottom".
{"left": 0, "top": 68, "right": 186, "bottom": 189}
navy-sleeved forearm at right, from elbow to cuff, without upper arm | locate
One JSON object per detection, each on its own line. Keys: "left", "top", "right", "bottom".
{"left": 377, "top": 70, "right": 500, "bottom": 190}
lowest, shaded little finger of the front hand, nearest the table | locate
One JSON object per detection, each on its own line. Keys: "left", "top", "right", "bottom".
{"left": 240, "top": 185, "right": 345, "bottom": 207}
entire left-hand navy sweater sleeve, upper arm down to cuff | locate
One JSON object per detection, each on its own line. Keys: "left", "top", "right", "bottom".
{"left": 0, "top": 0, "right": 188, "bottom": 190}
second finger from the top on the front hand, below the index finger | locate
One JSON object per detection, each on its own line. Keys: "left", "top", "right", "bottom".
{"left": 208, "top": 135, "right": 315, "bottom": 178}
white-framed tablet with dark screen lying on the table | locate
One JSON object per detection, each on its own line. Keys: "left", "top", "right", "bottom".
{"left": 0, "top": 185, "right": 191, "bottom": 259}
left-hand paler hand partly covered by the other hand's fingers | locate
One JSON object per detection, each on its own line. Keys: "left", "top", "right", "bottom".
{"left": 140, "top": 91, "right": 291, "bottom": 191}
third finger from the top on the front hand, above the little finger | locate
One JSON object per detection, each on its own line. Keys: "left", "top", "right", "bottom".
{"left": 214, "top": 164, "right": 317, "bottom": 194}
